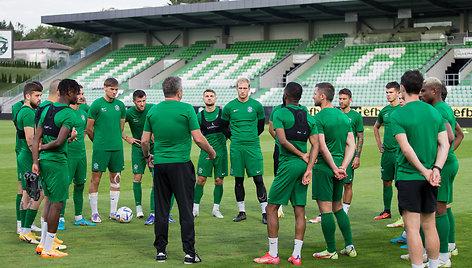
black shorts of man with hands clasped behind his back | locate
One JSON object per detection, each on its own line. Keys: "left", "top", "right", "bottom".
{"left": 395, "top": 180, "right": 438, "bottom": 213}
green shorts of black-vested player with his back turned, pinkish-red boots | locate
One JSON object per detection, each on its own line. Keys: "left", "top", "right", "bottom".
{"left": 267, "top": 158, "right": 308, "bottom": 206}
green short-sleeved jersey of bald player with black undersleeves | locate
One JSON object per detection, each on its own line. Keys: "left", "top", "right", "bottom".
{"left": 221, "top": 98, "right": 265, "bottom": 147}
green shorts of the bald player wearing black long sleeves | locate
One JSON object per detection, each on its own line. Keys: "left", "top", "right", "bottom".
{"left": 229, "top": 144, "right": 264, "bottom": 177}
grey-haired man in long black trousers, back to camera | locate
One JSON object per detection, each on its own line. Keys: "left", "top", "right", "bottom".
{"left": 141, "top": 76, "right": 216, "bottom": 264}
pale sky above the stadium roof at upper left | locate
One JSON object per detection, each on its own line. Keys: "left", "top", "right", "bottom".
{"left": 0, "top": 0, "right": 168, "bottom": 31}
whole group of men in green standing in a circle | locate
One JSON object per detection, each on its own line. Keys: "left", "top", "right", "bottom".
{"left": 12, "top": 71, "right": 463, "bottom": 267}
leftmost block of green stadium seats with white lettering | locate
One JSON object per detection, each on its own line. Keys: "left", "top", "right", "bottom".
{"left": 70, "top": 44, "right": 177, "bottom": 89}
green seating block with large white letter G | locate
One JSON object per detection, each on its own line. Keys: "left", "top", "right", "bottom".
{"left": 262, "top": 42, "right": 446, "bottom": 106}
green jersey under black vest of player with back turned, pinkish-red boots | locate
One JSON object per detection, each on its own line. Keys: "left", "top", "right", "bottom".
{"left": 271, "top": 105, "right": 318, "bottom": 161}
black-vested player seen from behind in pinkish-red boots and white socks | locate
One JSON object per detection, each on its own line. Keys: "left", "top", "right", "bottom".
{"left": 254, "top": 82, "right": 319, "bottom": 265}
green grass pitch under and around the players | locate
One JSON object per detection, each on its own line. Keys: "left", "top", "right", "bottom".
{"left": 0, "top": 121, "right": 472, "bottom": 267}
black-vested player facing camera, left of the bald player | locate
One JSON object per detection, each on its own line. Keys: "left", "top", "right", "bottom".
{"left": 193, "top": 89, "right": 231, "bottom": 218}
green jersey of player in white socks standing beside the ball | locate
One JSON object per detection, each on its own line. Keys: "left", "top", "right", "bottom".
{"left": 88, "top": 97, "right": 126, "bottom": 151}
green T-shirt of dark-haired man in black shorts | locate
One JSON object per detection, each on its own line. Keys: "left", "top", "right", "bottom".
{"left": 391, "top": 101, "right": 446, "bottom": 180}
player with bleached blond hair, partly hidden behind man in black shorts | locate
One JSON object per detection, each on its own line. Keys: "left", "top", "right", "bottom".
{"left": 419, "top": 77, "right": 459, "bottom": 267}
